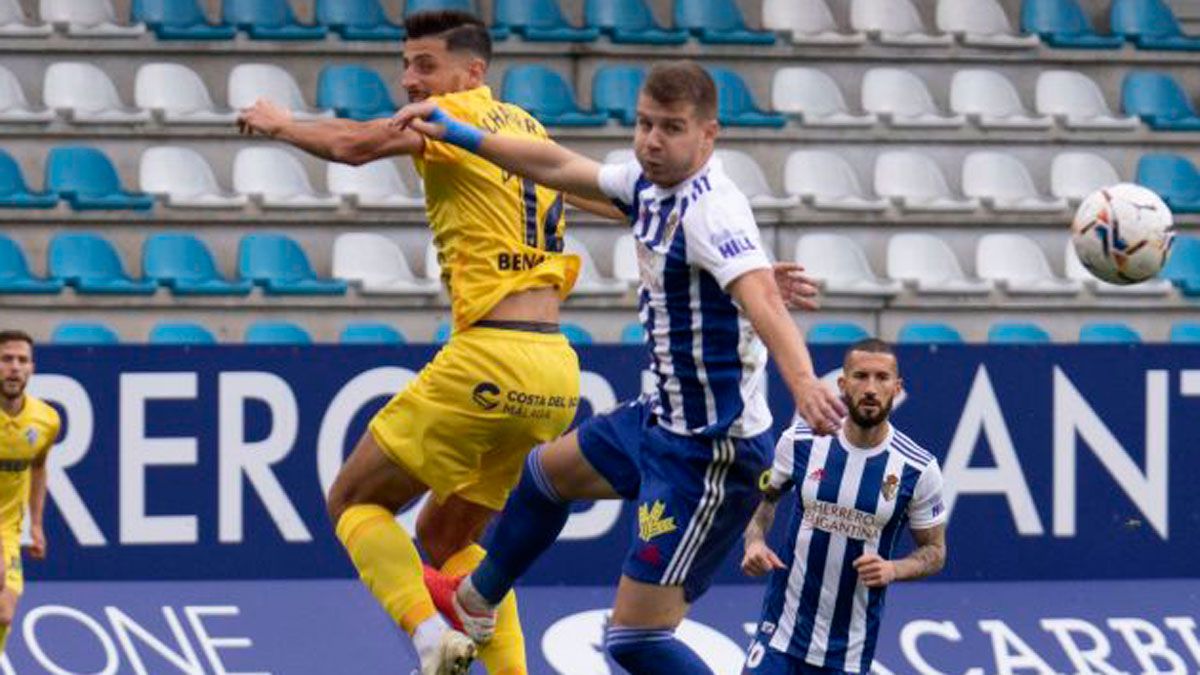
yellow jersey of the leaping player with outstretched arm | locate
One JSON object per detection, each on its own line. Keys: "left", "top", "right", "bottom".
{"left": 413, "top": 86, "right": 580, "bottom": 330}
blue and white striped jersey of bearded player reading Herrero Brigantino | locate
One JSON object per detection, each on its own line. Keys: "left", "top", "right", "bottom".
{"left": 760, "top": 422, "right": 946, "bottom": 673}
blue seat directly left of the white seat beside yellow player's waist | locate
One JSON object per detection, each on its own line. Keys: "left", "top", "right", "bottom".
{"left": 238, "top": 234, "right": 346, "bottom": 295}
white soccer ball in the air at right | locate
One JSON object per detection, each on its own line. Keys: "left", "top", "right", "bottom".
{"left": 1070, "top": 183, "right": 1175, "bottom": 285}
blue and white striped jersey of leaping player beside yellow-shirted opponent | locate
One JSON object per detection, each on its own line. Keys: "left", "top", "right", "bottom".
{"left": 600, "top": 157, "right": 772, "bottom": 438}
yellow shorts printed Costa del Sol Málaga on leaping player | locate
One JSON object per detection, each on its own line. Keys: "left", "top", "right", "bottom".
{"left": 370, "top": 327, "right": 580, "bottom": 510}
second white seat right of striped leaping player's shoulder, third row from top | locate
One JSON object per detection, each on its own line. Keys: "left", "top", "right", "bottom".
{"left": 784, "top": 150, "right": 888, "bottom": 211}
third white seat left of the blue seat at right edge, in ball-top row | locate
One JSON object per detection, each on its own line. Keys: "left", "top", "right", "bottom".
{"left": 875, "top": 150, "right": 979, "bottom": 213}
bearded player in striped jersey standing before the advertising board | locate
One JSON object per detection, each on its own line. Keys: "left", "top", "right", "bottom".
{"left": 742, "top": 339, "right": 946, "bottom": 675}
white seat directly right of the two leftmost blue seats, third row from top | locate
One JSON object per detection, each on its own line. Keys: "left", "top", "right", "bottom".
{"left": 138, "top": 145, "right": 250, "bottom": 209}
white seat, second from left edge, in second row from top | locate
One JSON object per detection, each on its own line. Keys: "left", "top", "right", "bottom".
{"left": 42, "top": 62, "right": 151, "bottom": 124}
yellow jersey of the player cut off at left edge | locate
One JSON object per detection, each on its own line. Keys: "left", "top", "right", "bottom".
{"left": 0, "top": 395, "right": 61, "bottom": 537}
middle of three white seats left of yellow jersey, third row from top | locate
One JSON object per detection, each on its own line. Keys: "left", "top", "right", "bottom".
{"left": 233, "top": 147, "right": 342, "bottom": 209}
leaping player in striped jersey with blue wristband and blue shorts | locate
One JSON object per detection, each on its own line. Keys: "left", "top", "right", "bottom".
{"left": 395, "top": 61, "right": 844, "bottom": 675}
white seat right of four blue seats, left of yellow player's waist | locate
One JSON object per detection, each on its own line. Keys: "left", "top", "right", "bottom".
{"left": 334, "top": 232, "right": 440, "bottom": 295}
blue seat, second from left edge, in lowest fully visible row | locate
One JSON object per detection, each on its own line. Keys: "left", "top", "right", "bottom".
{"left": 47, "top": 233, "right": 158, "bottom": 295}
